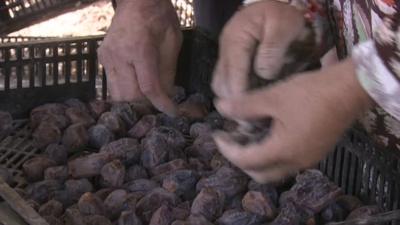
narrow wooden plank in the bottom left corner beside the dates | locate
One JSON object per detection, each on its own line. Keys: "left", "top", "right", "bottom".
{"left": 0, "top": 178, "right": 49, "bottom": 225}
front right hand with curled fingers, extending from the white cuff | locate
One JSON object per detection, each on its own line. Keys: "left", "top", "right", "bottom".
{"left": 215, "top": 60, "right": 371, "bottom": 182}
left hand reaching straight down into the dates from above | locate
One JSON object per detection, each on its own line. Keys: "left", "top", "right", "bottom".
{"left": 98, "top": 0, "right": 182, "bottom": 116}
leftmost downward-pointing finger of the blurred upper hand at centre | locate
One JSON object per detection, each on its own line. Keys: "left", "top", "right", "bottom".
{"left": 212, "top": 13, "right": 262, "bottom": 97}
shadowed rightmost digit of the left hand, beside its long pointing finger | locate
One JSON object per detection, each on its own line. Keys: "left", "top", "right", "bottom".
{"left": 160, "top": 26, "right": 183, "bottom": 96}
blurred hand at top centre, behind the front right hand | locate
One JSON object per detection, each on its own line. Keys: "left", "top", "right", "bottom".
{"left": 212, "top": 1, "right": 310, "bottom": 98}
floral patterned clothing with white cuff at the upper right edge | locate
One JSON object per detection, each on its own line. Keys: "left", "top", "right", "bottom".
{"left": 310, "top": 0, "right": 400, "bottom": 150}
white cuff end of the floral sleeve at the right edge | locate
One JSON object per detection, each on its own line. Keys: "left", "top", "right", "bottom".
{"left": 352, "top": 15, "right": 400, "bottom": 120}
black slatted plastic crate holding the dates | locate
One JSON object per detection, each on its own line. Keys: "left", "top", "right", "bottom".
{"left": 0, "top": 30, "right": 400, "bottom": 224}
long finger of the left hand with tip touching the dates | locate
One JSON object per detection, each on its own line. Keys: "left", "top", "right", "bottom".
{"left": 134, "top": 39, "right": 177, "bottom": 116}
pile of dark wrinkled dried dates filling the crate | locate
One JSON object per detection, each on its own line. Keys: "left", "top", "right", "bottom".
{"left": 0, "top": 89, "right": 380, "bottom": 225}
